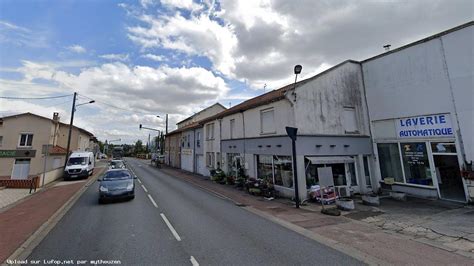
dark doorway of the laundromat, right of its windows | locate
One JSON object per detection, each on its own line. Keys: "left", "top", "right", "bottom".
{"left": 433, "top": 154, "right": 466, "bottom": 202}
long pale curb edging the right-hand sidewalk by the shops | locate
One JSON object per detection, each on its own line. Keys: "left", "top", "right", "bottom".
{"left": 143, "top": 163, "right": 386, "bottom": 265}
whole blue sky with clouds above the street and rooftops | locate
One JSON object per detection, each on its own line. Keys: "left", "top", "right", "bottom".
{"left": 0, "top": 0, "right": 474, "bottom": 143}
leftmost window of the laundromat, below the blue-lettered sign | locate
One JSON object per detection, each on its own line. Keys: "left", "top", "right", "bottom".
{"left": 377, "top": 143, "right": 404, "bottom": 183}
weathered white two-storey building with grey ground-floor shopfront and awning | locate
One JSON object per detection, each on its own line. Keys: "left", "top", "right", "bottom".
{"left": 204, "top": 61, "right": 372, "bottom": 198}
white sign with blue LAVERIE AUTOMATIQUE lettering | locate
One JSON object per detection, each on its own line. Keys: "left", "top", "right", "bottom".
{"left": 397, "top": 114, "right": 454, "bottom": 138}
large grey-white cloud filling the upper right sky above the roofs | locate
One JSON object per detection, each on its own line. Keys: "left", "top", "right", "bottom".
{"left": 128, "top": 0, "right": 472, "bottom": 89}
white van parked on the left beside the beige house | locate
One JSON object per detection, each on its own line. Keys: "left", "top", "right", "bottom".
{"left": 64, "top": 152, "right": 95, "bottom": 180}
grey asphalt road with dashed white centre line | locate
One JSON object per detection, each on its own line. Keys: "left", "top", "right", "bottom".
{"left": 29, "top": 158, "right": 362, "bottom": 265}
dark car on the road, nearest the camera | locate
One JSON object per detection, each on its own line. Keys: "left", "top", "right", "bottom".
{"left": 98, "top": 169, "right": 136, "bottom": 203}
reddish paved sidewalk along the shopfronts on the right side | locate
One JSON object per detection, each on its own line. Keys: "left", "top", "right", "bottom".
{"left": 161, "top": 167, "right": 474, "bottom": 265}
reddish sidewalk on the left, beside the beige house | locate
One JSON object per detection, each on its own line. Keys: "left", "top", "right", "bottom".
{"left": 0, "top": 168, "right": 102, "bottom": 262}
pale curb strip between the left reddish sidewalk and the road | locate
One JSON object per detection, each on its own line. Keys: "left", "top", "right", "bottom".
{"left": 2, "top": 167, "right": 106, "bottom": 265}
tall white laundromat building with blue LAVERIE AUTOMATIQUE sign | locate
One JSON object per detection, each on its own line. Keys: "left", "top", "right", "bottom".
{"left": 362, "top": 21, "right": 474, "bottom": 202}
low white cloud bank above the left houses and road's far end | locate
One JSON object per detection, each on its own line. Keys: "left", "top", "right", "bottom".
{"left": 0, "top": 61, "right": 229, "bottom": 142}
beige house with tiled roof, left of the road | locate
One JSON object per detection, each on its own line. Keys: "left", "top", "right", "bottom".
{"left": 0, "top": 113, "right": 95, "bottom": 182}
